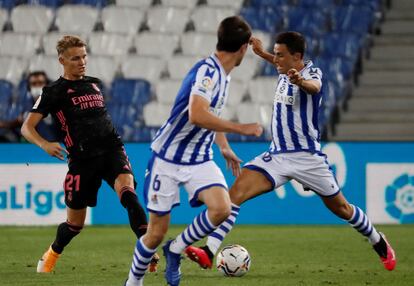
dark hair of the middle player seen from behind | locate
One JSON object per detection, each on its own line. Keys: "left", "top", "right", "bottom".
{"left": 216, "top": 16, "right": 252, "bottom": 53}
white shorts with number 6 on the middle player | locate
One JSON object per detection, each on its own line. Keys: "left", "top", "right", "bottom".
{"left": 144, "top": 154, "right": 228, "bottom": 215}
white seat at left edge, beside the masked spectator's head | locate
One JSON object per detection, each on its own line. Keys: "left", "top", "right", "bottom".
{"left": 0, "top": 56, "right": 27, "bottom": 85}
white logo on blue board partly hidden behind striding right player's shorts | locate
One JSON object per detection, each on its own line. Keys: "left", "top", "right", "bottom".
{"left": 275, "top": 143, "right": 347, "bottom": 199}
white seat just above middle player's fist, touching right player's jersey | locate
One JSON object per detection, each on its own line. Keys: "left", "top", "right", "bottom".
{"left": 237, "top": 102, "right": 273, "bottom": 126}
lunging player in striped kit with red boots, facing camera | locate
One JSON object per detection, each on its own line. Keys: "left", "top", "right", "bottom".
{"left": 185, "top": 32, "right": 396, "bottom": 270}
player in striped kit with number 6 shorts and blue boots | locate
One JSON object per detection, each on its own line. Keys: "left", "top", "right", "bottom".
{"left": 125, "top": 16, "right": 263, "bottom": 286}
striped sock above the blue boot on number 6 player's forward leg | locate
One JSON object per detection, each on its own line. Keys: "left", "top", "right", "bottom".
{"left": 170, "top": 210, "right": 216, "bottom": 254}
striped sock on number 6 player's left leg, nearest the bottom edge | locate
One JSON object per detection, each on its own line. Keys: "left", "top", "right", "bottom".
{"left": 126, "top": 237, "right": 156, "bottom": 286}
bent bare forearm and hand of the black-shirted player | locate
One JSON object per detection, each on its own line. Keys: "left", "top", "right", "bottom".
{"left": 21, "top": 112, "right": 69, "bottom": 161}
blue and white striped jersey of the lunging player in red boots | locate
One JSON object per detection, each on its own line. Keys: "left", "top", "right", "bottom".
{"left": 270, "top": 61, "right": 322, "bottom": 153}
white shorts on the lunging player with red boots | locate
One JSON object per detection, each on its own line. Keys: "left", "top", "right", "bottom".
{"left": 243, "top": 152, "right": 339, "bottom": 197}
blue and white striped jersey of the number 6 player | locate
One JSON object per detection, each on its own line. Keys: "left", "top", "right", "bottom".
{"left": 151, "top": 54, "right": 230, "bottom": 165}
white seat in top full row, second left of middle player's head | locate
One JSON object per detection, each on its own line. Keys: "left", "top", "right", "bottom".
{"left": 147, "top": 6, "right": 189, "bottom": 34}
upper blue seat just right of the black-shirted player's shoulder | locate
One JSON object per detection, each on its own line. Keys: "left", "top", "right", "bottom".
{"left": 110, "top": 78, "right": 151, "bottom": 107}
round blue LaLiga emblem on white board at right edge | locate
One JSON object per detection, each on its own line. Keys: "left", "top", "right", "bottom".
{"left": 385, "top": 174, "right": 414, "bottom": 223}
